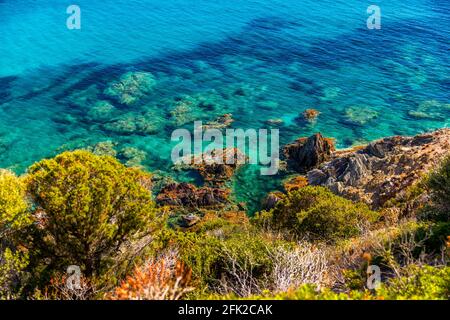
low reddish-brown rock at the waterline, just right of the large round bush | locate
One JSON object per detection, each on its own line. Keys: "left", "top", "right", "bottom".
{"left": 156, "top": 182, "right": 230, "bottom": 208}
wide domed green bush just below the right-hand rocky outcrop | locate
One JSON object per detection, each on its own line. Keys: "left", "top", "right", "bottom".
{"left": 256, "top": 186, "right": 378, "bottom": 241}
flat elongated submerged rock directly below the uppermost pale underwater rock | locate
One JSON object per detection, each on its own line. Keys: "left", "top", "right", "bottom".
{"left": 102, "top": 113, "right": 163, "bottom": 135}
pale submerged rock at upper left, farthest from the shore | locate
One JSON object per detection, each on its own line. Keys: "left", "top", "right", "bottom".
{"left": 104, "top": 72, "right": 156, "bottom": 105}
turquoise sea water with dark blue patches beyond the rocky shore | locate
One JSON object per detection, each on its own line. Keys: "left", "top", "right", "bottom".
{"left": 0, "top": 0, "right": 450, "bottom": 212}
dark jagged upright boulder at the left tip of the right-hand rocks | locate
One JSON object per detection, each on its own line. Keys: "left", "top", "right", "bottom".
{"left": 283, "top": 133, "right": 335, "bottom": 173}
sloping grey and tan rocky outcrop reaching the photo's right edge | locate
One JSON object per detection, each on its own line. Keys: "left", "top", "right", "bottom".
{"left": 307, "top": 129, "right": 450, "bottom": 209}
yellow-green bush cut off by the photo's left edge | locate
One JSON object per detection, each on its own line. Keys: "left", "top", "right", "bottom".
{"left": 0, "top": 169, "right": 31, "bottom": 299}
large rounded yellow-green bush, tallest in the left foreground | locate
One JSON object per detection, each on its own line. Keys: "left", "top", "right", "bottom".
{"left": 27, "top": 150, "right": 155, "bottom": 277}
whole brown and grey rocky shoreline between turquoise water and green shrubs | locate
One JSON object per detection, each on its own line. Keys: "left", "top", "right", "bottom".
{"left": 156, "top": 129, "right": 450, "bottom": 222}
